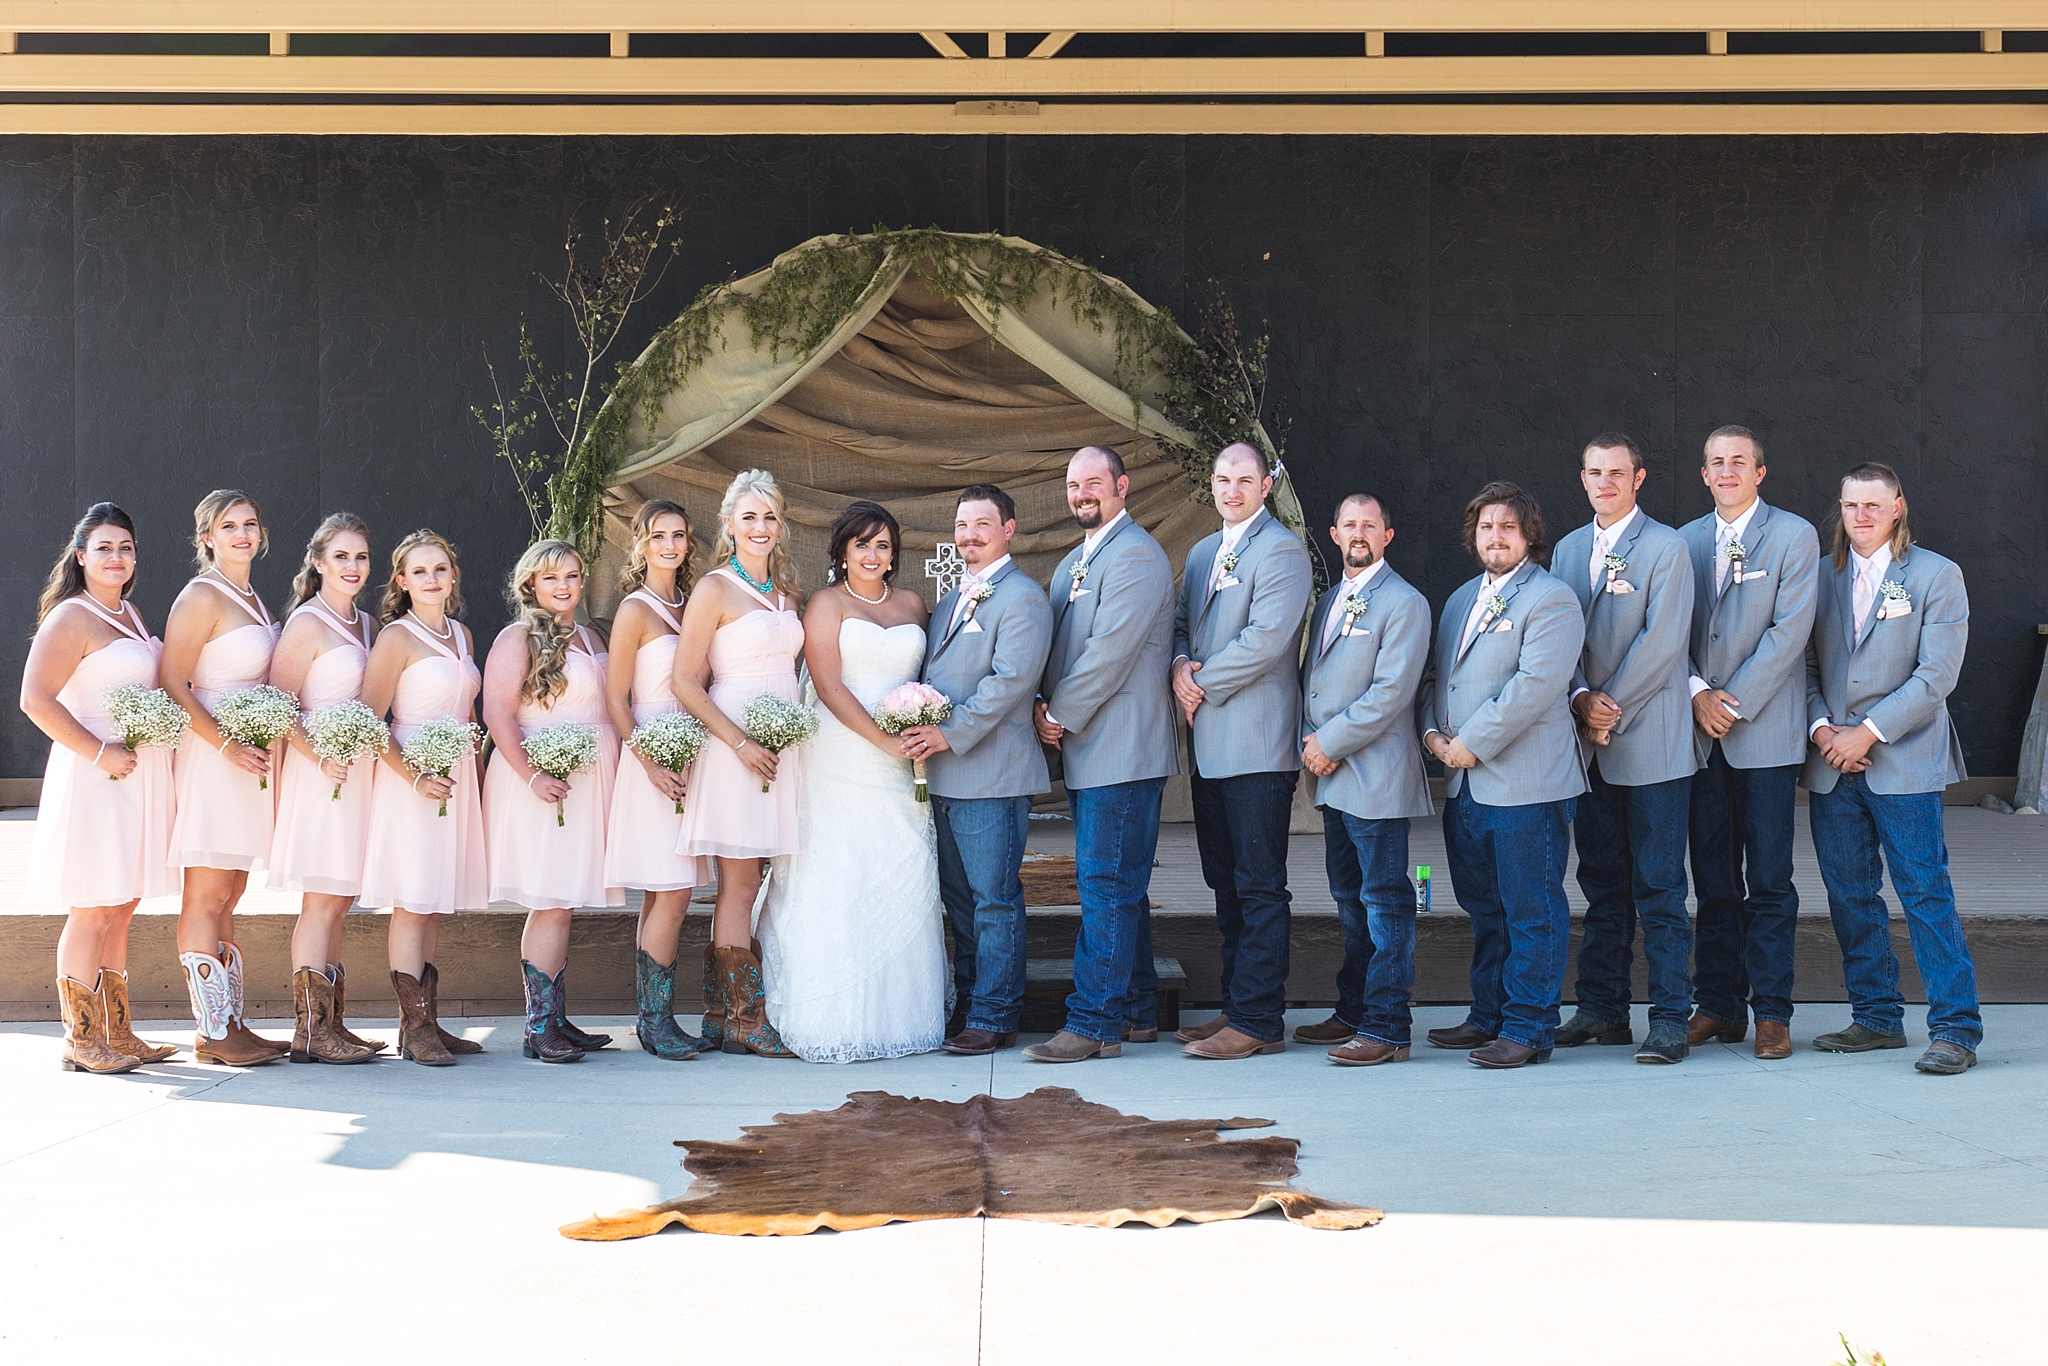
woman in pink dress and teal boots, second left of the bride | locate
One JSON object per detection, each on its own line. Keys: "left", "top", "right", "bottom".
{"left": 604, "top": 498, "right": 713, "bottom": 1061}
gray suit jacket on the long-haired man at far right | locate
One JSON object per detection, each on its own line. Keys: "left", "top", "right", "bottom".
{"left": 1800, "top": 545, "right": 1970, "bottom": 797}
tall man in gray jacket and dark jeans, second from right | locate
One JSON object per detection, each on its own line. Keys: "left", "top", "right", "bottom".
{"left": 1681, "top": 426, "right": 1821, "bottom": 1059}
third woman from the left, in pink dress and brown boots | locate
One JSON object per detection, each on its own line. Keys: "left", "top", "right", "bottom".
{"left": 268, "top": 512, "right": 383, "bottom": 1063}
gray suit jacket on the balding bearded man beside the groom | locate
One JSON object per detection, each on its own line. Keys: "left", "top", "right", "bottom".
{"left": 1040, "top": 516, "right": 1180, "bottom": 788}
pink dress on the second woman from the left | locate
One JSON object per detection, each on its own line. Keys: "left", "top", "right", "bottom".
{"left": 170, "top": 578, "right": 279, "bottom": 872}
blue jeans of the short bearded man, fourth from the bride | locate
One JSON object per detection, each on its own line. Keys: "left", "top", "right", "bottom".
{"left": 1323, "top": 807, "right": 1415, "bottom": 1047}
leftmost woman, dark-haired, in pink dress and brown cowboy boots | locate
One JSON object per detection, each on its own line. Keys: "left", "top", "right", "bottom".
{"left": 20, "top": 502, "right": 178, "bottom": 1071}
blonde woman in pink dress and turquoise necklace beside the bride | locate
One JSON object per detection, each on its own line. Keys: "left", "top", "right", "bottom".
{"left": 670, "top": 469, "right": 803, "bottom": 1057}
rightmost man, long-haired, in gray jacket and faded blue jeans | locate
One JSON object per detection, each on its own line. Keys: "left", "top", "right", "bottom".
{"left": 1800, "top": 465, "right": 1985, "bottom": 1075}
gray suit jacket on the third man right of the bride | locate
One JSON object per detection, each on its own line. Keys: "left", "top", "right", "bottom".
{"left": 1174, "top": 508, "right": 1315, "bottom": 778}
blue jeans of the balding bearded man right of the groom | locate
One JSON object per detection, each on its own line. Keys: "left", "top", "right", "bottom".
{"left": 1067, "top": 778, "right": 1165, "bottom": 1042}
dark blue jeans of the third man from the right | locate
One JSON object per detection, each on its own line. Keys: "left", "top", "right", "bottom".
{"left": 1573, "top": 770, "right": 1692, "bottom": 1024}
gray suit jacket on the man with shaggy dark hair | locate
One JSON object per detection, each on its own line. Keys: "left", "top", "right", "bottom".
{"left": 1421, "top": 559, "right": 1585, "bottom": 807}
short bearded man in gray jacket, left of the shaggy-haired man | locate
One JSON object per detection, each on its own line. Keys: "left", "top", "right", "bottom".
{"left": 1294, "top": 494, "right": 1434, "bottom": 1067}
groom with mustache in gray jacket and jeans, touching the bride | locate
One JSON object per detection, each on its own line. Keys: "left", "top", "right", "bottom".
{"left": 903, "top": 483, "right": 1053, "bottom": 1055}
